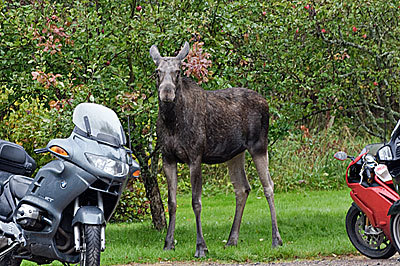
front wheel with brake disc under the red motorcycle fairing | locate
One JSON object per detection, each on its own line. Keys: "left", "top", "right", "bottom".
{"left": 346, "top": 203, "right": 396, "bottom": 259}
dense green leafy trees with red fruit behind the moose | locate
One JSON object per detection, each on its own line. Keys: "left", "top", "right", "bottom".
{"left": 0, "top": 0, "right": 400, "bottom": 219}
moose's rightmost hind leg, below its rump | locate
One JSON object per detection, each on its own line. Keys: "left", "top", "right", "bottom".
{"left": 250, "top": 151, "right": 282, "bottom": 247}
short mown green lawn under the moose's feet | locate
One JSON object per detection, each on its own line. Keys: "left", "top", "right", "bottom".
{"left": 24, "top": 190, "right": 356, "bottom": 265}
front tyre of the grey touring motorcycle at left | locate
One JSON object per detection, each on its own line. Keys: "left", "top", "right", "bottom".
{"left": 80, "top": 224, "right": 101, "bottom": 266}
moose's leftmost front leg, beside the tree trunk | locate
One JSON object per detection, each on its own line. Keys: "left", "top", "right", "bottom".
{"left": 163, "top": 159, "right": 178, "bottom": 250}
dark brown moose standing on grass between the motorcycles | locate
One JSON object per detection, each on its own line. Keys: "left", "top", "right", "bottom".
{"left": 150, "top": 42, "right": 282, "bottom": 257}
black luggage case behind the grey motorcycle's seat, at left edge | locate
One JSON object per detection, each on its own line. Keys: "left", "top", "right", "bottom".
{"left": 0, "top": 140, "right": 36, "bottom": 176}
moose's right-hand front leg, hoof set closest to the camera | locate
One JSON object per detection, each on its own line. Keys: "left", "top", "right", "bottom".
{"left": 189, "top": 159, "right": 208, "bottom": 258}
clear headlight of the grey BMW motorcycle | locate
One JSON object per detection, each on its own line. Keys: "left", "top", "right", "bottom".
{"left": 85, "top": 153, "right": 129, "bottom": 177}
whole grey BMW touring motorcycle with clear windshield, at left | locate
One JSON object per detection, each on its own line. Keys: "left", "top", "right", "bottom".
{"left": 0, "top": 103, "right": 139, "bottom": 266}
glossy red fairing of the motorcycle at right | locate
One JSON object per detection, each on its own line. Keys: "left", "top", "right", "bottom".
{"left": 346, "top": 152, "right": 400, "bottom": 240}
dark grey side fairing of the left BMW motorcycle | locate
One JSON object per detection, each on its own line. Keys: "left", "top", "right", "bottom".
{"left": 17, "top": 160, "right": 96, "bottom": 263}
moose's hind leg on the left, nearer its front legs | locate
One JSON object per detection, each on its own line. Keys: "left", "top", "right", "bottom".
{"left": 226, "top": 152, "right": 251, "bottom": 246}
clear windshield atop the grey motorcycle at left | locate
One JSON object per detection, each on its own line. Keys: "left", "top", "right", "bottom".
{"left": 72, "top": 103, "right": 126, "bottom": 146}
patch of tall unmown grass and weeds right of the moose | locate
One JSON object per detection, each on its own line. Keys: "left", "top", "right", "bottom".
{"left": 266, "top": 127, "right": 377, "bottom": 192}
